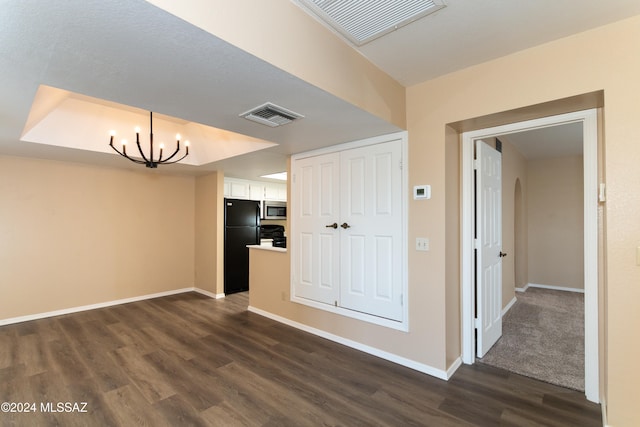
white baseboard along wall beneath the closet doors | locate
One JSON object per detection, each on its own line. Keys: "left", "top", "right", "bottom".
{"left": 248, "top": 306, "right": 452, "bottom": 380}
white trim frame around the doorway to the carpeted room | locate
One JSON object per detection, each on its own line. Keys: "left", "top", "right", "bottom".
{"left": 461, "top": 110, "right": 599, "bottom": 402}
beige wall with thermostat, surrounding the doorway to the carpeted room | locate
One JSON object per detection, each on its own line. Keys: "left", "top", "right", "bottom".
{"left": 407, "top": 17, "right": 640, "bottom": 425}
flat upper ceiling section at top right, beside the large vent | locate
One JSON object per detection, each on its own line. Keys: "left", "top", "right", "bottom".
{"left": 332, "top": 0, "right": 640, "bottom": 86}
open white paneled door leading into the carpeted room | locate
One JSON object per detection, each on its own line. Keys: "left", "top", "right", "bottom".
{"left": 476, "top": 140, "right": 503, "bottom": 357}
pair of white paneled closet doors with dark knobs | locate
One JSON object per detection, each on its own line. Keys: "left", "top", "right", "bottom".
{"left": 290, "top": 134, "right": 406, "bottom": 323}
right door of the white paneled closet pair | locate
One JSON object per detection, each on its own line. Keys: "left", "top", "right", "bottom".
{"left": 340, "top": 140, "right": 403, "bottom": 321}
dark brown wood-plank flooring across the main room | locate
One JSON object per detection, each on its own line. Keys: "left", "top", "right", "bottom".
{"left": 0, "top": 293, "right": 601, "bottom": 426}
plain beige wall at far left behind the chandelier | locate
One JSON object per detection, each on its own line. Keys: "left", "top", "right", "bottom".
{"left": 0, "top": 157, "right": 194, "bottom": 320}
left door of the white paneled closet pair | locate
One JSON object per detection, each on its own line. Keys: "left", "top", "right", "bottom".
{"left": 292, "top": 153, "right": 340, "bottom": 305}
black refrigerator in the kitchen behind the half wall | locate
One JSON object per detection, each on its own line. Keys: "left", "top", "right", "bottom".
{"left": 224, "top": 199, "right": 260, "bottom": 294}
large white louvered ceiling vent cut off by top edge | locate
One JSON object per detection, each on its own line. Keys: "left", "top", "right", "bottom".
{"left": 297, "top": 0, "right": 446, "bottom": 46}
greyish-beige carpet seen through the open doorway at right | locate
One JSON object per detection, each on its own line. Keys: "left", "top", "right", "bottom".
{"left": 478, "top": 288, "right": 584, "bottom": 391}
